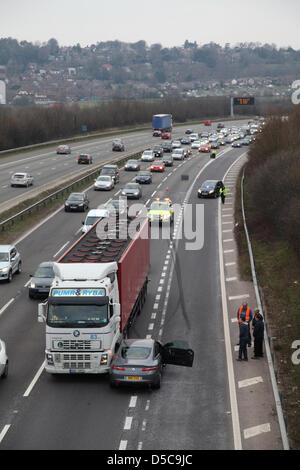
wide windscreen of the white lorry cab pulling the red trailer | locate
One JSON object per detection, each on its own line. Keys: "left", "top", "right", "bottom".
{"left": 47, "top": 303, "right": 109, "bottom": 328}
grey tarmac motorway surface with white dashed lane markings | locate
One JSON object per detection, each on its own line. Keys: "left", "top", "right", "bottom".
{"left": 0, "top": 122, "right": 282, "bottom": 450}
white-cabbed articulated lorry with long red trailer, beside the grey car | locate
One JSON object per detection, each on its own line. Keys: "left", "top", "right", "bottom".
{"left": 38, "top": 217, "right": 150, "bottom": 374}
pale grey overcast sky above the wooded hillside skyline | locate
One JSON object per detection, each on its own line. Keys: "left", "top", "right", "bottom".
{"left": 0, "top": 0, "right": 300, "bottom": 49}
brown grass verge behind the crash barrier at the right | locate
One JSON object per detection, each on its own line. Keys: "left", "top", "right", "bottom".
{"left": 235, "top": 171, "right": 300, "bottom": 449}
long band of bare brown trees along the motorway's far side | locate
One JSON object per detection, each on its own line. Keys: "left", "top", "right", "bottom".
{"left": 0, "top": 97, "right": 290, "bottom": 150}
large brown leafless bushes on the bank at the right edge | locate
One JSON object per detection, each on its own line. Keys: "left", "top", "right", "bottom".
{"left": 246, "top": 105, "right": 300, "bottom": 257}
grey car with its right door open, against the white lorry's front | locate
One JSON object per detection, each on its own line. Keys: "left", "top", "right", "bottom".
{"left": 109, "top": 339, "right": 194, "bottom": 389}
